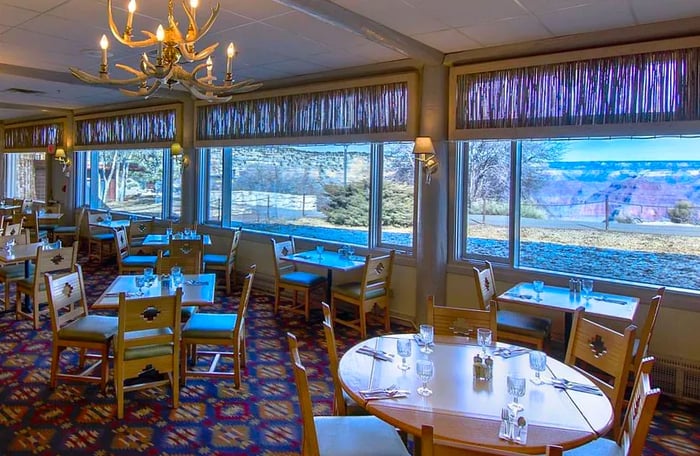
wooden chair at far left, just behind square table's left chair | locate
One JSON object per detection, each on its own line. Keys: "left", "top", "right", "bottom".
{"left": 15, "top": 244, "right": 78, "bottom": 329}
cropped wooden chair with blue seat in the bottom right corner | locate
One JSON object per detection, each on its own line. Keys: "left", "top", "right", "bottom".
{"left": 564, "top": 357, "right": 661, "bottom": 456}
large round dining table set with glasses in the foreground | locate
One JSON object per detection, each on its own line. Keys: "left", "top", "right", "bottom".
{"left": 338, "top": 334, "right": 613, "bottom": 454}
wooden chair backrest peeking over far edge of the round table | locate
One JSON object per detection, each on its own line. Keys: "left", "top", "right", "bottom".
{"left": 427, "top": 296, "right": 498, "bottom": 341}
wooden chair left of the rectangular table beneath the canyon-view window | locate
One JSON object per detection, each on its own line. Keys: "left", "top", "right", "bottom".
{"left": 473, "top": 261, "right": 552, "bottom": 351}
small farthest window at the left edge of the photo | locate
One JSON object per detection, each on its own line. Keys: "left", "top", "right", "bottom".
{"left": 3, "top": 152, "right": 46, "bottom": 201}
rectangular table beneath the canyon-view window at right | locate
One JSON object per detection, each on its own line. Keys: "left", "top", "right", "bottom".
{"left": 497, "top": 282, "right": 639, "bottom": 343}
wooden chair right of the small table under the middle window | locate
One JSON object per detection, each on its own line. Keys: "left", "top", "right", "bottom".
{"left": 331, "top": 250, "right": 396, "bottom": 339}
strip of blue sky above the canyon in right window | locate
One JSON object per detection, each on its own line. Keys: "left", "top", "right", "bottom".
{"left": 562, "top": 138, "right": 700, "bottom": 161}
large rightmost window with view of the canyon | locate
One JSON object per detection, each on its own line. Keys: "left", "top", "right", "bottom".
{"left": 461, "top": 137, "right": 700, "bottom": 290}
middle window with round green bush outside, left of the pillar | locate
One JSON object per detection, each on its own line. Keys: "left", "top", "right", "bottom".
{"left": 203, "top": 143, "right": 414, "bottom": 248}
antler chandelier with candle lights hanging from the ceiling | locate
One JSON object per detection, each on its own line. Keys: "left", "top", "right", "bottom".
{"left": 70, "top": 0, "right": 262, "bottom": 101}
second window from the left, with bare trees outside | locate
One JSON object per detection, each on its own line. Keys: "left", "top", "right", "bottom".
{"left": 83, "top": 149, "right": 181, "bottom": 218}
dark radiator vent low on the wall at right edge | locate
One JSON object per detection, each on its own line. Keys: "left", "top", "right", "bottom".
{"left": 652, "top": 356, "right": 700, "bottom": 402}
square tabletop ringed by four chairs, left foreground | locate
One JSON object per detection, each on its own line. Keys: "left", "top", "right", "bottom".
{"left": 92, "top": 274, "right": 216, "bottom": 310}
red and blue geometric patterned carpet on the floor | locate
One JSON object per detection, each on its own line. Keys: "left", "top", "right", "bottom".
{"left": 0, "top": 256, "right": 700, "bottom": 456}
